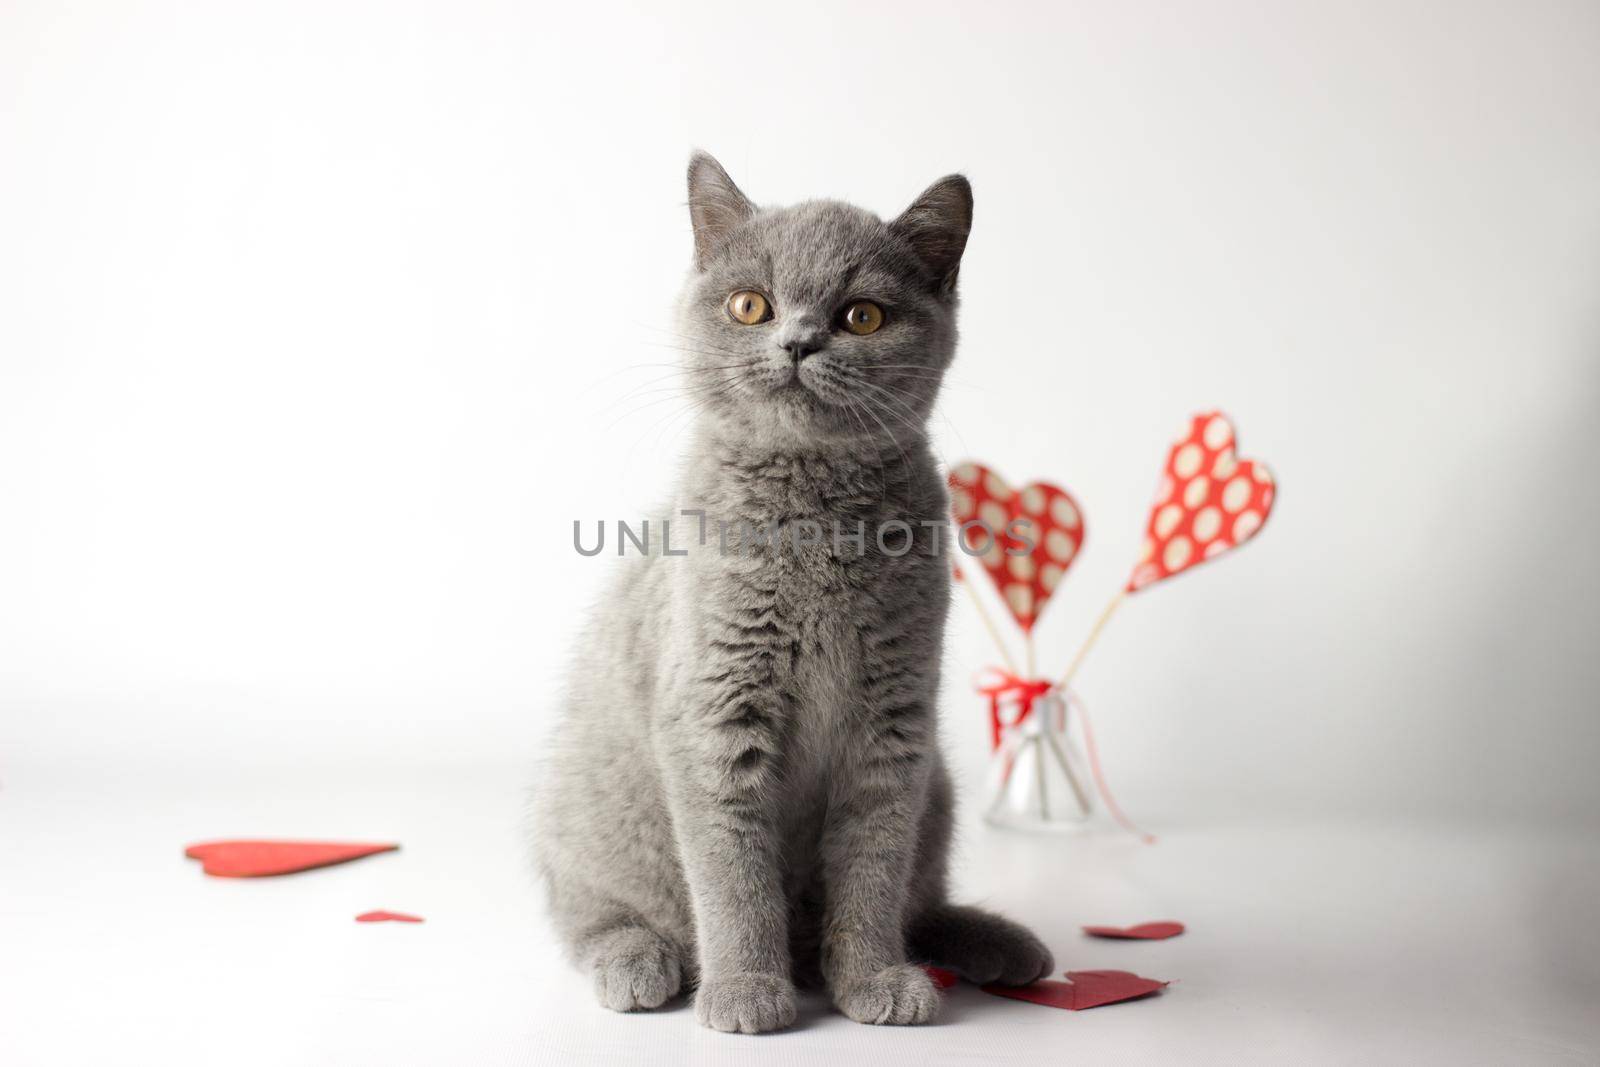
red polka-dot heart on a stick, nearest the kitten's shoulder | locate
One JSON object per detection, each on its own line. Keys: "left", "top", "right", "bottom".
{"left": 950, "top": 462, "right": 1085, "bottom": 632}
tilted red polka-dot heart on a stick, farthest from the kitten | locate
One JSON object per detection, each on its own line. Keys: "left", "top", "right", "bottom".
{"left": 1126, "top": 411, "right": 1277, "bottom": 592}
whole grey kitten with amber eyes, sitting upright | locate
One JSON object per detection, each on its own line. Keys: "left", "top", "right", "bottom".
{"left": 534, "top": 154, "right": 1053, "bottom": 1033}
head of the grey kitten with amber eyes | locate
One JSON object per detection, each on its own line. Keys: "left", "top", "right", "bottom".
{"left": 680, "top": 152, "right": 973, "bottom": 446}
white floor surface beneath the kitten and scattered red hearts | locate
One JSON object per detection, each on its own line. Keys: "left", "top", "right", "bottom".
{"left": 0, "top": 771, "right": 1600, "bottom": 1067}
